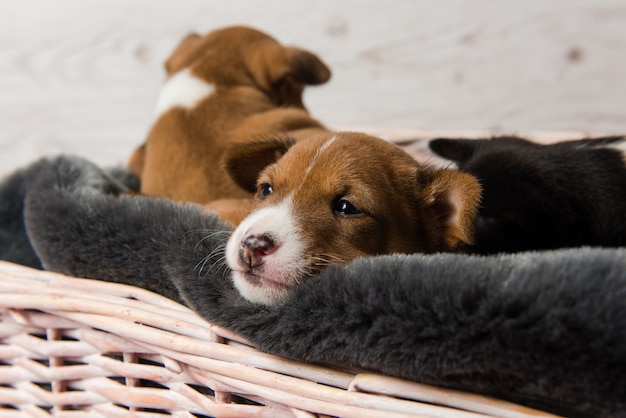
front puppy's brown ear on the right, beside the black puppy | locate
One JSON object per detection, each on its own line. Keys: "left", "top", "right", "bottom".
{"left": 417, "top": 168, "right": 481, "bottom": 250}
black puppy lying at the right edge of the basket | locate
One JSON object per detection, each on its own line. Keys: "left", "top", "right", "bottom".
{"left": 430, "top": 137, "right": 626, "bottom": 253}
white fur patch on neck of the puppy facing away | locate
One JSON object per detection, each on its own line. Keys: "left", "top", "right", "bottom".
{"left": 155, "top": 68, "right": 215, "bottom": 119}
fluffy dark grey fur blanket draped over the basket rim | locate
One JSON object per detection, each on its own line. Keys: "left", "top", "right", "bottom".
{"left": 0, "top": 157, "right": 626, "bottom": 417}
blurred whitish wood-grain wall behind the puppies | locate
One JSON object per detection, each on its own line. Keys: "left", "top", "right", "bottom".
{"left": 0, "top": 0, "right": 626, "bottom": 174}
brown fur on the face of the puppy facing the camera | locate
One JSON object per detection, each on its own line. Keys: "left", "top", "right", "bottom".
{"left": 236, "top": 132, "right": 480, "bottom": 255}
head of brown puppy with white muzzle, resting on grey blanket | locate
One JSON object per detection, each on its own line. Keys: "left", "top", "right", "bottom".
{"left": 225, "top": 132, "right": 481, "bottom": 305}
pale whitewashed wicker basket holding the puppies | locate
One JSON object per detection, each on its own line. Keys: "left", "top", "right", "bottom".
{"left": 0, "top": 262, "right": 560, "bottom": 418}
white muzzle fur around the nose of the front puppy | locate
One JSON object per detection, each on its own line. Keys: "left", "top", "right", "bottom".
{"left": 226, "top": 197, "right": 306, "bottom": 305}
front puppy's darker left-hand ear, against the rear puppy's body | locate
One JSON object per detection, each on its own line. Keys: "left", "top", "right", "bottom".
{"left": 222, "top": 136, "right": 295, "bottom": 193}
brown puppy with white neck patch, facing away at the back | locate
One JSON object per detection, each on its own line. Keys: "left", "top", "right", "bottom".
{"left": 129, "top": 26, "right": 330, "bottom": 224}
